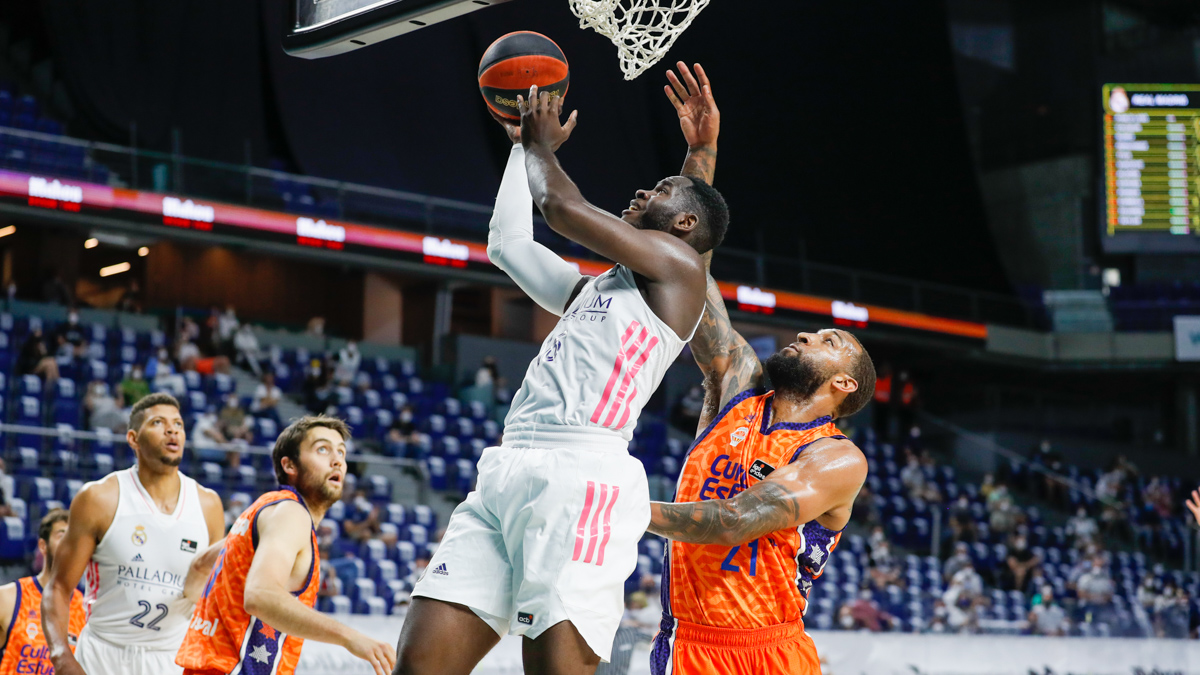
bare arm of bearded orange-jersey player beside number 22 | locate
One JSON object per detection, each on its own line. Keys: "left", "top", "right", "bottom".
{"left": 244, "top": 502, "right": 396, "bottom": 675}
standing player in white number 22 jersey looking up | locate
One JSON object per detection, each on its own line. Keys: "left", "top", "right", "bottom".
{"left": 42, "top": 394, "right": 224, "bottom": 675}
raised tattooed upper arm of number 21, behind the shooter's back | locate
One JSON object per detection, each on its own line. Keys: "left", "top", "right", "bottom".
{"left": 690, "top": 251, "right": 762, "bottom": 432}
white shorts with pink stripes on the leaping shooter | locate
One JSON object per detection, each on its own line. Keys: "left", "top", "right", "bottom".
{"left": 413, "top": 447, "right": 650, "bottom": 661}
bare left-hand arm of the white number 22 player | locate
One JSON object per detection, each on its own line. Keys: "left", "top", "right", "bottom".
{"left": 42, "top": 479, "right": 120, "bottom": 675}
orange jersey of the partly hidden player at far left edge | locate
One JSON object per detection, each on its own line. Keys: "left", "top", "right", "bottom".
{"left": 0, "top": 577, "right": 88, "bottom": 675}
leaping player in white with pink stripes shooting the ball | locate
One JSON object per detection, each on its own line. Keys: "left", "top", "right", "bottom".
{"left": 396, "top": 64, "right": 728, "bottom": 675}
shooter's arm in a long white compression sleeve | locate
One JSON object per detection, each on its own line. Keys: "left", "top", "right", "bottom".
{"left": 487, "top": 115, "right": 587, "bottom": 316}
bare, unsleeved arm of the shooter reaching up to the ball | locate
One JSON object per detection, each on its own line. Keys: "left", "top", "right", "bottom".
{"left": 521, "top": 86, "right": 704, "bottom": 296}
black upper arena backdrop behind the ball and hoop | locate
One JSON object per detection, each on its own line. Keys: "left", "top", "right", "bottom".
{"left": 18, "top": 0, "right": 1008, "bottom": 289}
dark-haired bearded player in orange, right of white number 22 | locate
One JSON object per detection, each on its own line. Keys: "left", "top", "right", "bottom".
{"left": 175, "top": 416, "right": 396, "bottom": 675}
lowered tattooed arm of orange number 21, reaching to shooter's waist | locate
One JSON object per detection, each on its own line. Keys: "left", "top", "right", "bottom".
{"left": 649, "top": 438, "right": 866, "bottom": 546}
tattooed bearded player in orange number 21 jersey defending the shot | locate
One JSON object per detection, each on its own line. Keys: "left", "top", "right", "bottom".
{"left": 649, "top": 255, "right": 875, "bottom": 675}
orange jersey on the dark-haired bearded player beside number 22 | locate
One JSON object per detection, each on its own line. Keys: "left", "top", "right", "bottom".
{"left": 175, "top": 485, "right": 320, "bottom": 675}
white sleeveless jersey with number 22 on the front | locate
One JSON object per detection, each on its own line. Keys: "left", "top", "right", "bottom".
{"left": 84, "top": 466, "right": 209, "bottom": 650}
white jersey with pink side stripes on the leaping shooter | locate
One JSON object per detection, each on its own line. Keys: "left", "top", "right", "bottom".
{"left": 504, "top": 265, "right": 700, "bottom": 444}
